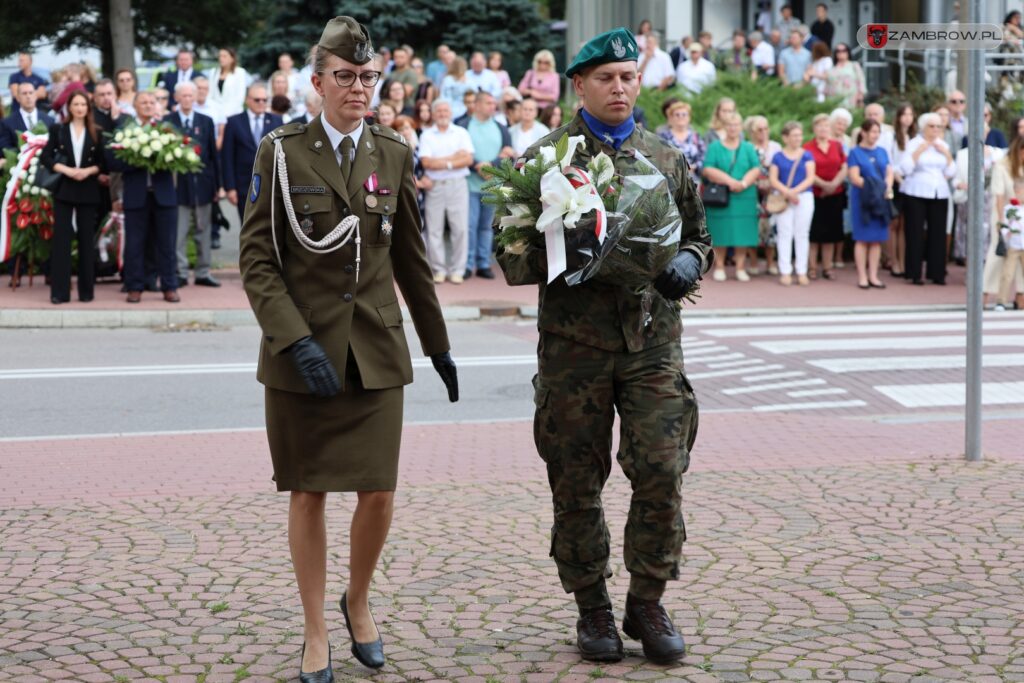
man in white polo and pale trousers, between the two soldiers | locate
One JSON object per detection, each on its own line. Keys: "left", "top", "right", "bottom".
{"left": 420, "top": 98, "right": 473, "bottom": 285}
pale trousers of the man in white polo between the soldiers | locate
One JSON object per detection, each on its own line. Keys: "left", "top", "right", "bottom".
{"left": 424, "top": 178, "right": 469, "bottom": 275}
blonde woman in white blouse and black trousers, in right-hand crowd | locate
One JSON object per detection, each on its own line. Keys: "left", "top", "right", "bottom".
{"left": 899, "top": 113, "right": 956, "bottom": 285}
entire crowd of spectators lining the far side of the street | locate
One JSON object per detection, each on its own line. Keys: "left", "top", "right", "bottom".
{"left": 6, "top": 10, "right": 1024, "bottom": 308}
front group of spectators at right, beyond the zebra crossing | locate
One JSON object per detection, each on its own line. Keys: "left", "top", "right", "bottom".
{"left": 659, "top": 91, "right": 1024, "bottom": 309}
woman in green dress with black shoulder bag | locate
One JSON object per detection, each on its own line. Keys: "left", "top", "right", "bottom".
{"left": 703, "top": 114, "right": 761, "bottom": 283}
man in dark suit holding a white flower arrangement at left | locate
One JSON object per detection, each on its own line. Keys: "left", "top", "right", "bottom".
{"left": 106, "top": 92, "right": 181, "bottom": 303}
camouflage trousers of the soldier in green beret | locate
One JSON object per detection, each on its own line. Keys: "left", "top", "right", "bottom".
{"left": 534, "top": 332, "right": 697, "bottom": 593}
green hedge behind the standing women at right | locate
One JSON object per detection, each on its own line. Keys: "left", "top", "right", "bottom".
{"left": 637, "top": 72, "right": 861, "bottom": 140}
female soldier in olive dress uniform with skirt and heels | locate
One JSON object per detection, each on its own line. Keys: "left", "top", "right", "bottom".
{"left": 240, "top": 16, "right": 459, "bottom": 683}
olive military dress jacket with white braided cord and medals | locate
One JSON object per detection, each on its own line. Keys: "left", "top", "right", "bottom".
{"left": 239, "top": 118, "right": 450, "bottom": 393}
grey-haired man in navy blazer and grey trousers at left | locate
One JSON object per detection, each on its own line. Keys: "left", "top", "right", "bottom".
{"left": 164, "top": 81, "right": 220, "bottom": 287}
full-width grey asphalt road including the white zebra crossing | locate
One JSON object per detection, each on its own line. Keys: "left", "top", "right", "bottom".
{"left": 0, "top": 311, "right": 1024, "bottom": 440}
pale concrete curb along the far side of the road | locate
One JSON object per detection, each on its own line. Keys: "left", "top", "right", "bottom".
{"left": 0, "top": 303, "right": 966, "bottom": 329}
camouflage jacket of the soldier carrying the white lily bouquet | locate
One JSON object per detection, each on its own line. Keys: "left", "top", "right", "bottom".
{"left": 498, "top": 114, "right": 714, "bottom": 352}
